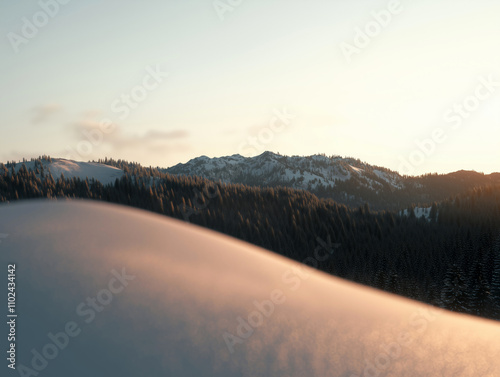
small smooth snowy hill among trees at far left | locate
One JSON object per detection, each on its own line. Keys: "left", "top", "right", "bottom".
{"left": 5, "top": 158, "right": 124, "bottom": 185}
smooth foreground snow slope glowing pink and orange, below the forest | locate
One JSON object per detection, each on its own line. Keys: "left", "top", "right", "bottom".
{"left": 0, "top": 200, "right": 500, "bottom": 377}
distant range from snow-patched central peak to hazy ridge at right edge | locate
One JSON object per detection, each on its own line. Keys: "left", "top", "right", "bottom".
{"left": 165, "top": 152, "right": 500, "bottom": 210}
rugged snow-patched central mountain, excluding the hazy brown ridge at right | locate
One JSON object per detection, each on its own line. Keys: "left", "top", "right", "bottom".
{"left": 167, "top": 152, "right": 403, "bottom": 191}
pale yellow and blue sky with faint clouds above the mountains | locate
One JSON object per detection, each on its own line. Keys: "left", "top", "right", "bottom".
{"left": 0, "top": 0, "right": 500, "bottom": 174}
